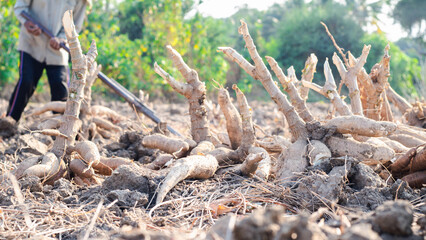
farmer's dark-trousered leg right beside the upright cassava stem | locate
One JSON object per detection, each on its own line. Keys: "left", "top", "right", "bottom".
{"left": 46, "top": 65, "right": 68, "bottom": 101}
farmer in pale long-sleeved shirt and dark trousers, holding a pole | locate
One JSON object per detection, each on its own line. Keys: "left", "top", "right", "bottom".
{"left": 0, "top": 0, "right": 91, "bottom": 124}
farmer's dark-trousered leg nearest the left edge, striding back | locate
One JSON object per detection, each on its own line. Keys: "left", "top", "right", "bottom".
{"left": 7, "top": 51, "right": 43, "bottom": 121}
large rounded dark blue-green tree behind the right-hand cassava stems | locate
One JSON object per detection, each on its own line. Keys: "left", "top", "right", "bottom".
{"left": 268, "top": 2, "right": 363, "bottom": 84}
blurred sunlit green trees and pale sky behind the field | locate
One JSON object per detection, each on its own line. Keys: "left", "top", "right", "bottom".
{"left": 0, "top": 0, "right": 426, "bottom": 101}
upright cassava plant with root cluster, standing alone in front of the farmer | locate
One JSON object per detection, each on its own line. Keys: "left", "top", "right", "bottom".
{"left": 3, "top": 12, "right": 132, "bottom": 185}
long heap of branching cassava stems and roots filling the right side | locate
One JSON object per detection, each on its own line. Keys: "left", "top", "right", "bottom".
{"left": 144, "top": 21, "right": 426, "bottom": 204}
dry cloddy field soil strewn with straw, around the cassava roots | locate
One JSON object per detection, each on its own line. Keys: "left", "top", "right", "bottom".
{"left": 0, "top": 95, "right": 426, "bottom": 240}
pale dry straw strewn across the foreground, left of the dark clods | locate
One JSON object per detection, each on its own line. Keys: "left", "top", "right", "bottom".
{"left": 0, "top": 170, "right": 297, "bottom": 239}
